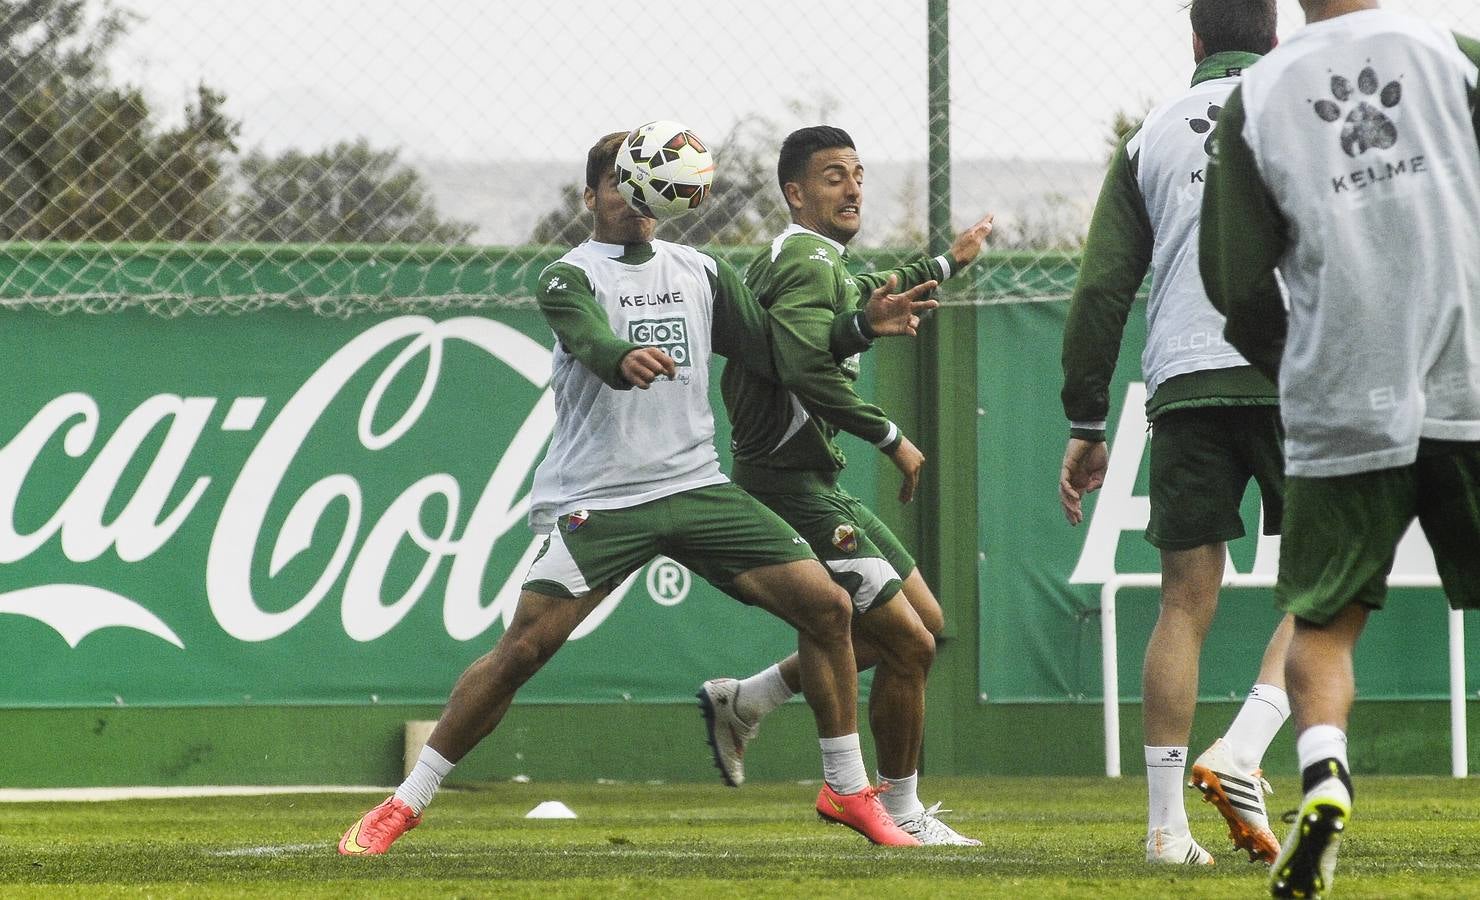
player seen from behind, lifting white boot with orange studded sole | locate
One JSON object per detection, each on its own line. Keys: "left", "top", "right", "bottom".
{"left": 1060, "top": 0, "right": 1292, "bottom": 864}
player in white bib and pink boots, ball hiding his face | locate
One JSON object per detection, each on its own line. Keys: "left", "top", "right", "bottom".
{"left": 339, "top": 132, "right": 934, "bottom": 854}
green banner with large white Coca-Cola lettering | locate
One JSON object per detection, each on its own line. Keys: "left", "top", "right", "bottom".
{"left": 0, "top": 299, "right": 872, "bottom": 708}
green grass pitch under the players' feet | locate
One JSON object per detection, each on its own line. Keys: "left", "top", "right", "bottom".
{"left": 0, "top": 777, "right": 1480, "bottom": 900}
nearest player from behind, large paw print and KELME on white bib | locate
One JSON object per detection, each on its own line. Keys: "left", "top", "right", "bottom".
{"left": 1200, "top": 0, "right": 1480, "bottom": 897}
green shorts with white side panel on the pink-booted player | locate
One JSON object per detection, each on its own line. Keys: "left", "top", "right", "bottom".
{"left": 524, "top": 484, "right": 817, "bottom": 600}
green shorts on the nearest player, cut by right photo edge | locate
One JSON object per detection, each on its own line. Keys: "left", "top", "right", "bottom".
{"left": 1274, "top": 441, "right": 1480, "bottom": 625}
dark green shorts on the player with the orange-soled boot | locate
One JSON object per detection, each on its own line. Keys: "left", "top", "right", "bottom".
{"left": 1146, "top": 406, "right": 1285, "bottom": 551}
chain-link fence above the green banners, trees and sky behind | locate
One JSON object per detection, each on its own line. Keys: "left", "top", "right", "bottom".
{"left": 0, "top": 0, "right": 1480, "bottom": 314}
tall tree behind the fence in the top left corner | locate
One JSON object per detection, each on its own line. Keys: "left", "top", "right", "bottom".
{"left": 0, "top": 0, "right": 240, "bottom": 240}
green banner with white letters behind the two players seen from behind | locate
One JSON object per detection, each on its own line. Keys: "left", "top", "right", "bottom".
{"left": 977, "top": 302, "right": 1480, "bottom": 702}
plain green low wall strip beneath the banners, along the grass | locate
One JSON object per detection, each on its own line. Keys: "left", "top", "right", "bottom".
{"left": 0, "top": 702, "right": 1480, "bottom": 788}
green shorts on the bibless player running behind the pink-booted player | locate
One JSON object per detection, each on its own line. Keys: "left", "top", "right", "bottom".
{"left": 755, "top": 488, "right": 915, "bottom": 613}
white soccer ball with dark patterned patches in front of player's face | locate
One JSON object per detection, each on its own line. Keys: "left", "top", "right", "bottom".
{"left": 617, "top": 121, "right": 715, "bottom": 219}
